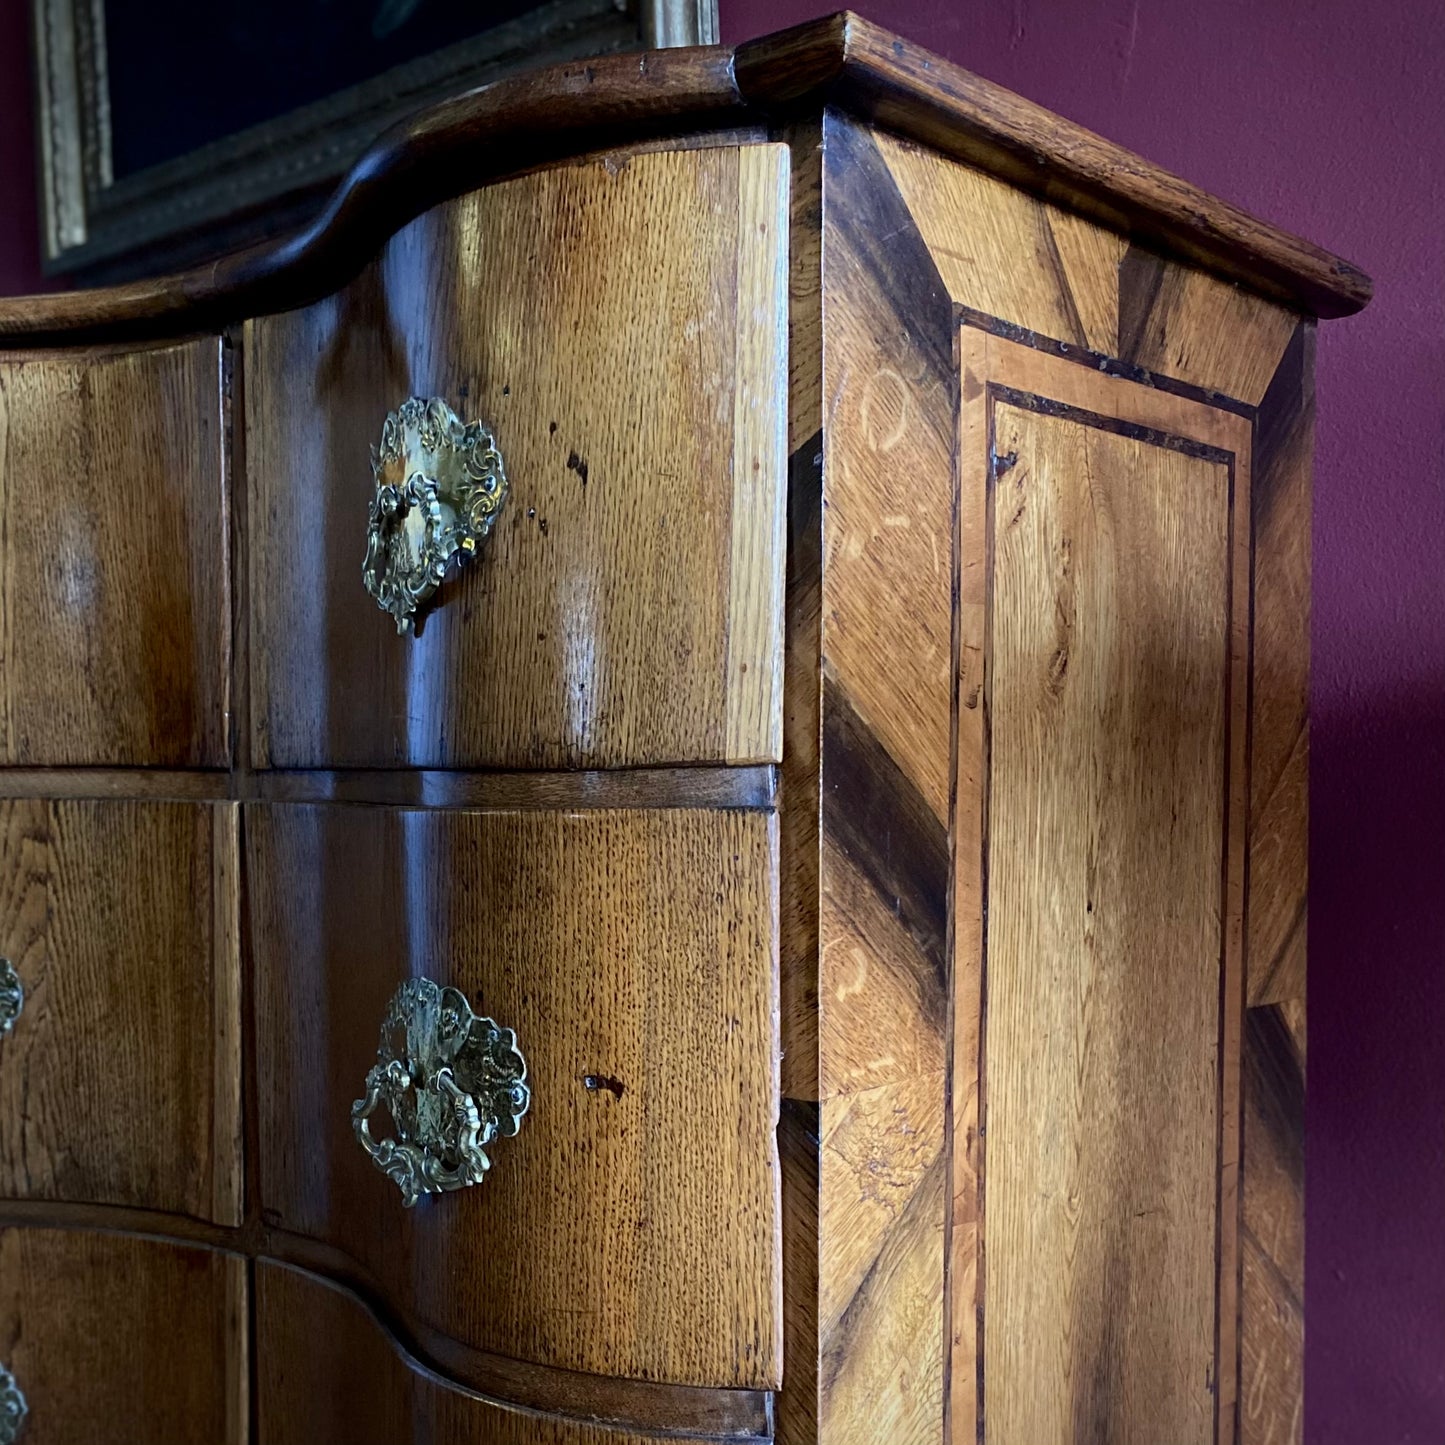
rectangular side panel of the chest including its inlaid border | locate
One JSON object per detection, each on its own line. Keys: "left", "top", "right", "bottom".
{"left": 951, "top": 325, "right": 1251, "bottom": 1442}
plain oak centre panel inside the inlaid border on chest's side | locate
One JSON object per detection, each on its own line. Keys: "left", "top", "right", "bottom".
{"left": 983, "top": 406, "right": 1230, "bottom": 1445}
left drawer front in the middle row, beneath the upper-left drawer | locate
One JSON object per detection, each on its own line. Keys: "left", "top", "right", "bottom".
{"left": 0, "top": 799, "right": 241, "bottom": 1224}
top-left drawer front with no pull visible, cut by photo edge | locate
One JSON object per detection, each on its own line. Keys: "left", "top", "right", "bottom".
{"left": 0, "top": 338, "right": 230, "bottom": 767}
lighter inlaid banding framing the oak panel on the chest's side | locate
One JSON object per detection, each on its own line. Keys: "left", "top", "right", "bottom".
{"left": 949, "top": 330, "right": 1253, "bottom": 1445}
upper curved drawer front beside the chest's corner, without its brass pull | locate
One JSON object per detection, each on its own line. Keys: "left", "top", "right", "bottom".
{"left": 246, "top": 145, "right": 788, "bottom": 767}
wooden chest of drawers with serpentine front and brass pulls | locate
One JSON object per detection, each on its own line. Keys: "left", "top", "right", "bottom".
{"left": 0, "top": 17, "right": 1368, "bottom": 1445}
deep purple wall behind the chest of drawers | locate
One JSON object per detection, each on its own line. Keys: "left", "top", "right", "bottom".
{"left": 0, "top": 0, "right": 1445, "bottom": 1445}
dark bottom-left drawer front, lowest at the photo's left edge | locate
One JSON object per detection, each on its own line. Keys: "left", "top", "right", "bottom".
{"left": 0, "top": 1228, "right": 247, "bottom": 1445}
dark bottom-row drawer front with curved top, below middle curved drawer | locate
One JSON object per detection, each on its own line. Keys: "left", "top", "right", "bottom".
{"left": 256, "top": 1261, "right": 766, "bottom": 1445}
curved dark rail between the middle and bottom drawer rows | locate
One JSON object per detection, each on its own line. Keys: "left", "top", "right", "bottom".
{"left": 0, "top": 1199, "right": 773, "bottom": 1445}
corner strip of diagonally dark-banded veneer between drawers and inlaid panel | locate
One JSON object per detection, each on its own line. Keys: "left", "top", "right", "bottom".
{"left": 779, "top": 114, "right": 955, "bottom": 1445}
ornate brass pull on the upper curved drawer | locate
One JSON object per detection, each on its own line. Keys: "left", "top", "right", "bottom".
{"left": 361, "top": 396, "right": 507, "bottom": 633}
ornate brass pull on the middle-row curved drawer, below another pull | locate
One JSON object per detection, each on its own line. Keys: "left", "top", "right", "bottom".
{"left": 351, "top": 978, "right": 532, "bottom": 1208}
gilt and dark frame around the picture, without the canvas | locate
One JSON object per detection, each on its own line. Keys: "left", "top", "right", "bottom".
{"left": 32, "top": 0, "right": 718, "bottom": 285}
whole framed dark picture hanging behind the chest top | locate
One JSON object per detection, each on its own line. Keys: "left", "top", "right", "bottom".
{"left": 32, "top": 0, "right": 717, "bottom": 282}
